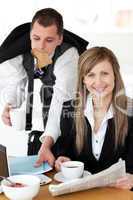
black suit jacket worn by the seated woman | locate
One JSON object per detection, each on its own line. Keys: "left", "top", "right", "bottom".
{"left": 60, "top": 101, "right": 133, "bottom": 173}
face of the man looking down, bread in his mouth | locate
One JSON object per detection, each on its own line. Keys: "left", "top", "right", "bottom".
{"left": 30, "top": 21, "right": 63, "bottom": 55}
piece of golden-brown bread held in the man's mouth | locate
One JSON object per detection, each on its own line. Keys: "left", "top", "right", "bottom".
{"left": 31, "top": 48, "right": 52, "bottom": 69}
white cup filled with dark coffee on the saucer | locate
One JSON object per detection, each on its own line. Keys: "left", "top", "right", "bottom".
{"left": 61, "top": 161, "right": 84, "bottom": 179}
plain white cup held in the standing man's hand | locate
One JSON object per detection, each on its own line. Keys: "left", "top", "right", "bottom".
{"left": 10, "top": 108, "right": 26, "bottom": 131}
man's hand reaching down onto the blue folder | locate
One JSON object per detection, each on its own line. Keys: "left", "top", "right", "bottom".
{"left": 35, "top": 136, "right": 55, "bottom": 167}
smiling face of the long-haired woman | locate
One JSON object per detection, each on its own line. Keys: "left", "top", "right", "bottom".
{"left": 83, "top": 60, "right": 115, "bottom": 97}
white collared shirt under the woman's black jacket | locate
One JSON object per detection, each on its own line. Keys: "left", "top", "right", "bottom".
{"left": 84, "top": 95, "right": 113, "bottom": 160}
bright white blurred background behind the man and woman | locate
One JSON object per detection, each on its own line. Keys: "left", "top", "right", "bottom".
{"left": 0, "top": 0, "right": 133, "bottom": 156}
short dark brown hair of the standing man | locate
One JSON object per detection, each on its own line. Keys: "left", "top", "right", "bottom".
{"left": 31, "top": 8, "right": 63, "bottom": 35}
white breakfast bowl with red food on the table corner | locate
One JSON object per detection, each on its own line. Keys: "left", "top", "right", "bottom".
{"left": 1, "top": 175, "right": 40, "bottom": 200}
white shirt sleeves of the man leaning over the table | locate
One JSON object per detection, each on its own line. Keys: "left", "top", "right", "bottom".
{"left": 1, "top": 47, "right": 79, "bottom": 142}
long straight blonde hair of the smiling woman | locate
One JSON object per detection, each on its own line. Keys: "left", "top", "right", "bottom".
{"left": 74, "top": 47, "right": 128, "bottom": 153}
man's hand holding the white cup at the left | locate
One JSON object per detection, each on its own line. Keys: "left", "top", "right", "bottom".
{"left": 1, "top": 104, "right": 12, "bottom": 126}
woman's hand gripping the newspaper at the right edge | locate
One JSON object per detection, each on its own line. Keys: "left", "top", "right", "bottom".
{"left": 112, "top": 174, "right": 133, "bottom": 190}
